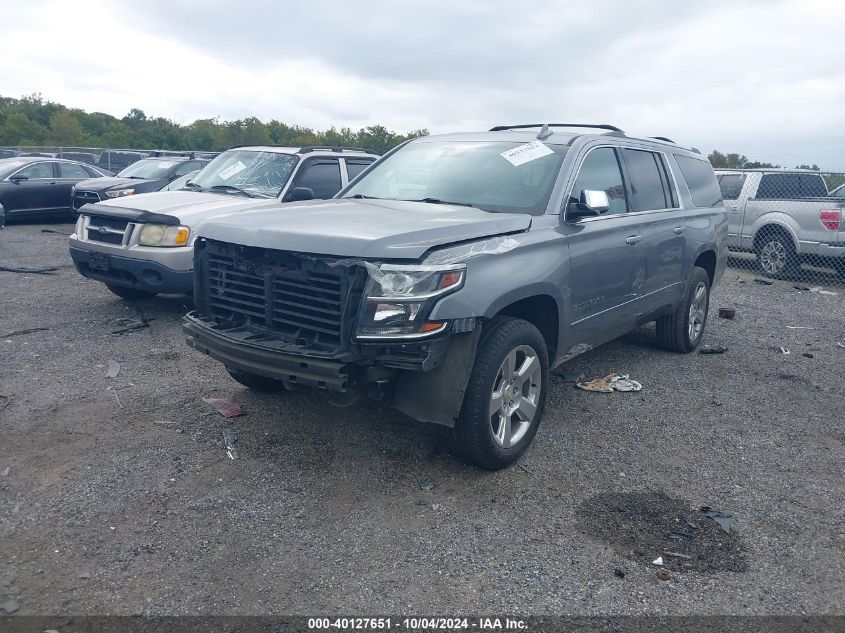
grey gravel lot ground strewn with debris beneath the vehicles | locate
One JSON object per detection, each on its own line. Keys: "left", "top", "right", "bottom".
{"left": 0, "top": 224, "right": 845, "bottom": 615}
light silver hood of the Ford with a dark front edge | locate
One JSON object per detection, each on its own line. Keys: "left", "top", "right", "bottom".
{"left": 89, "top": 191, "right": 281, "bottom": 228}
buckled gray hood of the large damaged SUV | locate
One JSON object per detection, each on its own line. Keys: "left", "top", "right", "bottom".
{"left": 199, "top": 198, "right": 531, "bottom": 259}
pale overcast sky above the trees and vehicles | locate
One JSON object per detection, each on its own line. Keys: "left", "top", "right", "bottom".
{"left": 0, "top": 0, "right": 845, "bottom": 170}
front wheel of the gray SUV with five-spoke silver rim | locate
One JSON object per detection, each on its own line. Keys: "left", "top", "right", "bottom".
{"left": 452, "top": 317, "right": 549, "bottom": 470}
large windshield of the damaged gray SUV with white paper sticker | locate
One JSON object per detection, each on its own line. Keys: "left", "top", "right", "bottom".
{"left": 343, "top": 140, "right": 568, "bottom": 215}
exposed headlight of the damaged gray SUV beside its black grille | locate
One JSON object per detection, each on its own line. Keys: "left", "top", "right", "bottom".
{"left": 357, "top": 264, "right": 466, "bottom": 339}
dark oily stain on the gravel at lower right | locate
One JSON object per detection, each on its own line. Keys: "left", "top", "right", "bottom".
{"left": 576, "top": 493, "right": 748, "bottom": 572}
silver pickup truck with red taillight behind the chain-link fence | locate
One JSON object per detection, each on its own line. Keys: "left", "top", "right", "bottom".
{"left": 716, "top": 169, "right": 845, "bottom": 277}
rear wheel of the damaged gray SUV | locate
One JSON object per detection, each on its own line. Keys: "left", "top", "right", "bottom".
{"left": 656, "top": 266, "right": 710, "bottom": 354}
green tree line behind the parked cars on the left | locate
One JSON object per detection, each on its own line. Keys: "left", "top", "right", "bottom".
{"left": 0, "top": 94, "right": 428, "bottom": 154}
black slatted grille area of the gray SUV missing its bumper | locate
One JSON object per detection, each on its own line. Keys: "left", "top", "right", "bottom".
{"left": 204, "top": 240, "right": 363, "bottom": 348}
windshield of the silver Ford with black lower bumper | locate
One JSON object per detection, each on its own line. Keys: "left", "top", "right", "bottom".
{"left": 191, "top": 150, "right": 299, "bottom": 198}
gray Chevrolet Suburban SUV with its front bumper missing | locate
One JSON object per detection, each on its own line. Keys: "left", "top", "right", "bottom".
{"left": 184, "top": 124, "right": 728, "bottom": 469}
